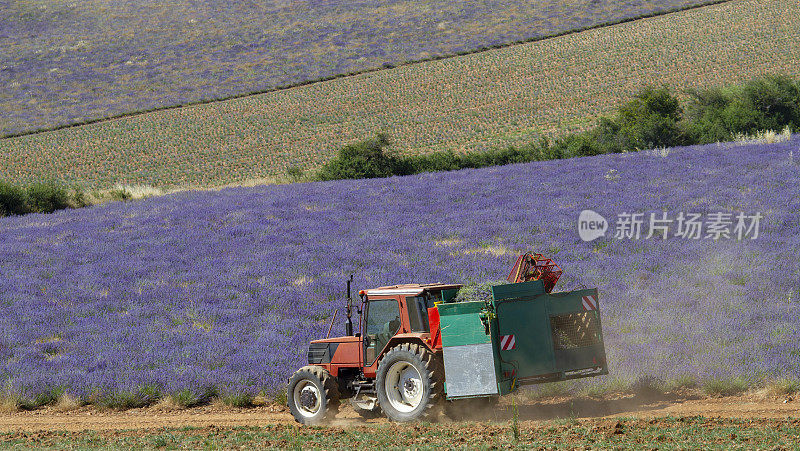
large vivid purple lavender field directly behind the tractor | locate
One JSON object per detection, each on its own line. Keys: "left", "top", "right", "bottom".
{"left": 0, "top": 139, "right": 800, "bottom": 406}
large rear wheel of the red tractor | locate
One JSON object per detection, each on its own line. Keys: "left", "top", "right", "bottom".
{"left": 375, "top": 343, "right": 444, "bottom": 422}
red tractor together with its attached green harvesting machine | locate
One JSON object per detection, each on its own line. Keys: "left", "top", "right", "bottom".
{"left": 287, "top": 254, "right": 608, "bottom": 424}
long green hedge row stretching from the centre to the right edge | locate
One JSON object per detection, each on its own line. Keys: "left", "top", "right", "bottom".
{"left": 318, "top": 75, "right": 800, "bottom": 180}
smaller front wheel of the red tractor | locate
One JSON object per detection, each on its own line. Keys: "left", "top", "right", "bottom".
{"left": 286, "top": 365, "right": 339, "bottom": 424}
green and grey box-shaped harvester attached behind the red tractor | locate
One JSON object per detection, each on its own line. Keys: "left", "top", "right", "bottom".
{"left": 436, "top": 280, "right": 608, "bottom": 399}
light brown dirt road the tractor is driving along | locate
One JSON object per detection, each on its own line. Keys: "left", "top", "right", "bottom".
{"left": 0, "top": 395, "right": 800, "bottom": 432}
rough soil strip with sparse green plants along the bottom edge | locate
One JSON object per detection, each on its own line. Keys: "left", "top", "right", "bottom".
{"left": 0, "top": 417, "right": 800, "bottom": 449}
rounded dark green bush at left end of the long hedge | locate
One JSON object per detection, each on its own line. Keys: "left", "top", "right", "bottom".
{"left": 316, "top": 133, "right": 408, "bottom": 180}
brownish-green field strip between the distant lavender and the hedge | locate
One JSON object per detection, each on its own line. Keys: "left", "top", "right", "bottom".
{"left": 0, "top": 0, "right": 800, "bottom": 186}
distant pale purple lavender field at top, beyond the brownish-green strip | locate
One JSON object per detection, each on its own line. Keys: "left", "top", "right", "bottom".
{"left": 0, "top": 0, "right": 720, "bottom": 135}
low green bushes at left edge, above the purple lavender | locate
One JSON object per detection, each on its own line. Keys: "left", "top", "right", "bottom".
{"left": 0, "top": 181, "right": 89, "bottom": 217}
